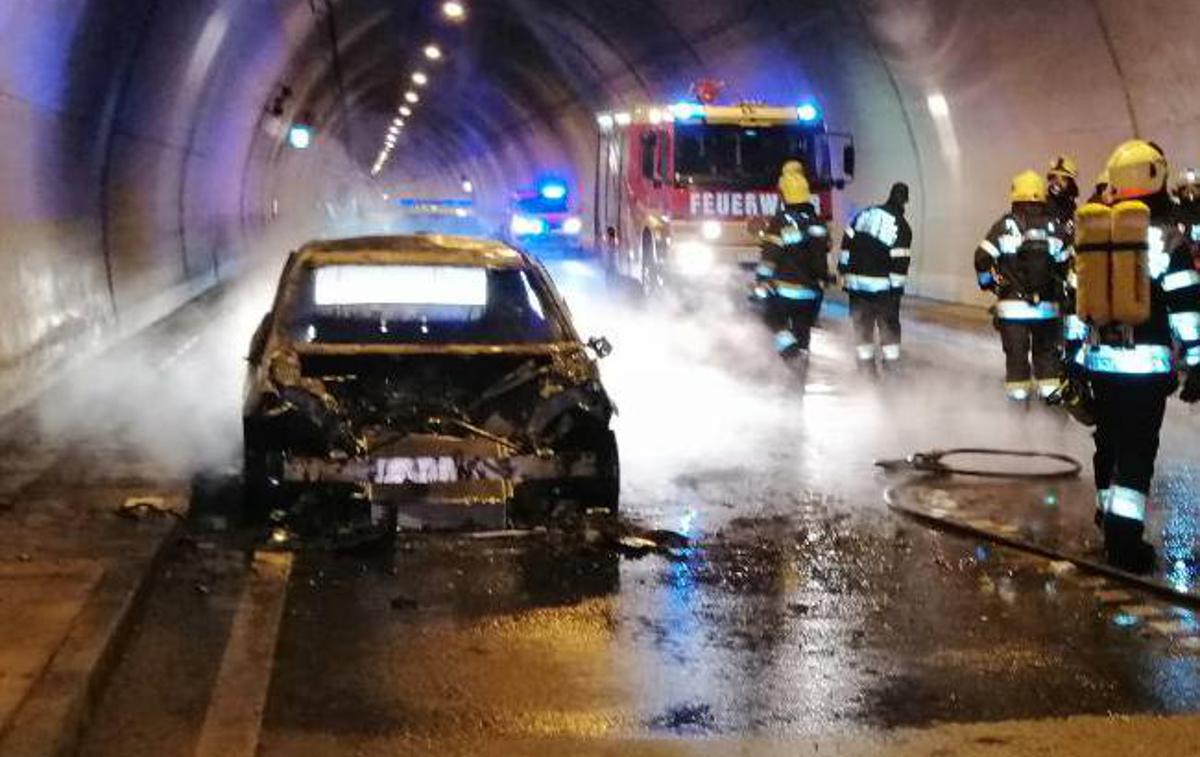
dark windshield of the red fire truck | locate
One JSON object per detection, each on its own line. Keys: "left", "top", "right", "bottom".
{"left": 674, "top": 124, "right": 812, "bottom": 190}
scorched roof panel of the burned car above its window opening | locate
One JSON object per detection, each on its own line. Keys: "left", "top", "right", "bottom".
{"left": 295, "top": 234, "right": 534, "bottom": 269}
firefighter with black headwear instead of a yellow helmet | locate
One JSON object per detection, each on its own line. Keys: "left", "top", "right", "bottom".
{"left": 838, "top": 182, "right": 912, "bottom": 373}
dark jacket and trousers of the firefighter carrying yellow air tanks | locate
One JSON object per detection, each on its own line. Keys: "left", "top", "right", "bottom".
{"left": 1075, "top": 192, "right": 1200, "bottom": 561}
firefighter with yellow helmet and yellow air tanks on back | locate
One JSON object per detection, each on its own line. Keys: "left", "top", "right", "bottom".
{"left": 1076, "top": 139, "right": 1200, "bottom": 571}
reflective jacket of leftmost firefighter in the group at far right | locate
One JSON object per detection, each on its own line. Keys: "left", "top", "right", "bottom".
{"left": 974, "top": 203, "right": 1070, "bottom": 322}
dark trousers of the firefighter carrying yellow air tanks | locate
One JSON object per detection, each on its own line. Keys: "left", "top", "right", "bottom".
{"left": 1088, "top": 373, "right": 1175, "bottom": 522}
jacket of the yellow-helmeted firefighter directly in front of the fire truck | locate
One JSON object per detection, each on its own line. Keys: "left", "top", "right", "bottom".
{"left": 755, "top": 203, "right": 829, "bottom": 300}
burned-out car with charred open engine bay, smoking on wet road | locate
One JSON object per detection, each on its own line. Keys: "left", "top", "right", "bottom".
{"left": 244, "top": 235, "right": 619, "bottom": 527}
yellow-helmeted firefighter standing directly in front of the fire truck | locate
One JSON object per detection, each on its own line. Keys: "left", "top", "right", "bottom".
{"left": 755, "top": 161, "right": 829, "bottom": 367}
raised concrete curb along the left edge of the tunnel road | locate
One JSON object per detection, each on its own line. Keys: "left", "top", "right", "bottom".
{"left": 0, "top": 519, "right": 180, "bottom": 757}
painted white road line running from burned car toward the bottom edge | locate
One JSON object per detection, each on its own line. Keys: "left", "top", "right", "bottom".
{"left": 196, "top": 552, "right": 293, "bottom": 757}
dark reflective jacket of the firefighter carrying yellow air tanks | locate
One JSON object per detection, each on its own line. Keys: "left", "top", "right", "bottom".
{"left": 1075, "top": 194, "right": 1200, "bottom": 376}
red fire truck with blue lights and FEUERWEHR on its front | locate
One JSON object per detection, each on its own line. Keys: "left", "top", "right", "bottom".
{"left": 594, "top": 87, "right": 854, "bottom": 294}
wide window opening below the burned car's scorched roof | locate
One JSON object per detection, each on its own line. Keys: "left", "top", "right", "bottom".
{"left": 289, "top": 264, "right": 565, "bottom": 344}
